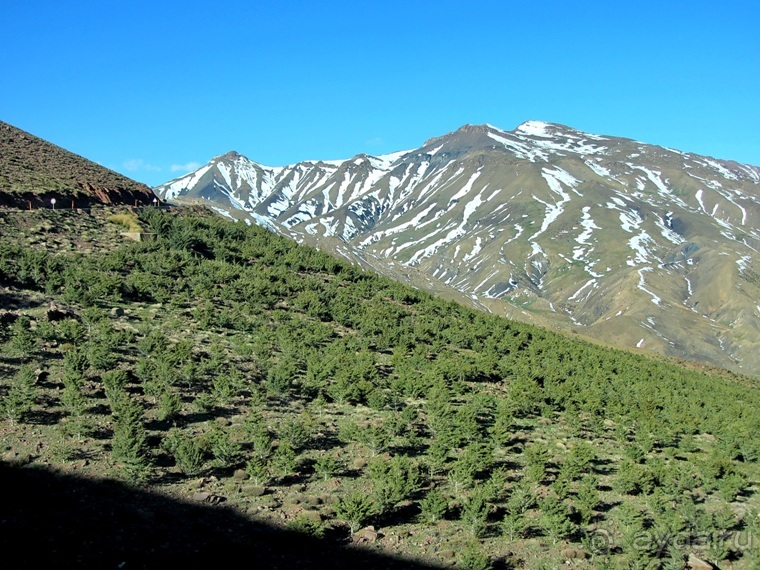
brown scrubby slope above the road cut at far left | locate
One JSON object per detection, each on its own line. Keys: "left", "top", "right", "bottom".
{"left": 0, "top": 121, "right": 155, "bottom": 208}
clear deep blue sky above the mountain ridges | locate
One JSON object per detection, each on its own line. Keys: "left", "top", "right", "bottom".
{"left": 0, "top": 0, "right": 760, "bottom": 185}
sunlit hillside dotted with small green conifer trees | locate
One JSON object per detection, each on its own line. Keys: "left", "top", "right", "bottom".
{"left": 0, "top": 208, "right": 760, "bottom": 569}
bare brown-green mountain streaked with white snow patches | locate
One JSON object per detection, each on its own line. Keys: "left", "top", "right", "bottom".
{"left": 156, "top": 121, "right": 760, "bottom": 374}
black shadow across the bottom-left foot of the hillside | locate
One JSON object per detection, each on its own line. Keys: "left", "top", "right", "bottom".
{"left": 0, "top": 463, "right": 434, "bottom": 570}
